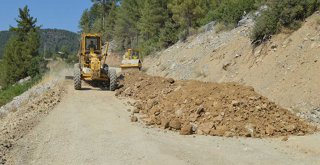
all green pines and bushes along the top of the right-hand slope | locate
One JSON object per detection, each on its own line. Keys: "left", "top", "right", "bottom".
{"left": 79, "top": 0, "right": 320, "bottom": 54}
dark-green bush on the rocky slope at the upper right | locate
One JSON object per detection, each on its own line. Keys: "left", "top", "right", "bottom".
{"left": 251, "top": 0, "right": 320, "bottom": 43}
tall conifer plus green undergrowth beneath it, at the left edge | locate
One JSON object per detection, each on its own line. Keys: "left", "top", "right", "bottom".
{"left": 0, "top": 6, "right": 45, "bottom": 106}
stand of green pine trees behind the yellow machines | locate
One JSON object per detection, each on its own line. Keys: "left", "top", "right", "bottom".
{"left": 79, "top": 0, "right": 262, "bottom": 54}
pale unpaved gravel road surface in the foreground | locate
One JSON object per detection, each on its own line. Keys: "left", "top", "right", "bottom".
{"left": 4, "top": 80, "right": 320, "bottom": 165}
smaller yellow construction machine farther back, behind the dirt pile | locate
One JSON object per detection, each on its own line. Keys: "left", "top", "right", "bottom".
{"left": 120, "top": 49, "right": 142, "bottom": 71}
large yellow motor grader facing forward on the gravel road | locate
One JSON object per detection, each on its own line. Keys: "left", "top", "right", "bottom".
{"left": 74, "top": 33, "right": 117, "bottom": 91}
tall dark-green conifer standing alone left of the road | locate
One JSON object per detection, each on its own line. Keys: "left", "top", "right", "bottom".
{"left": 3, "top": 6, "right": 41, "bottom": 85}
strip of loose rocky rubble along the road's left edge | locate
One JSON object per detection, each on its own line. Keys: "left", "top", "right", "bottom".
{"left": 0, "top": 80, "right": 63, "bottom": 164}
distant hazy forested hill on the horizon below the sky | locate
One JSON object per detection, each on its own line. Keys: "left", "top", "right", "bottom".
{"left": 0, "top": 29, "right": 79, "bottom": 58}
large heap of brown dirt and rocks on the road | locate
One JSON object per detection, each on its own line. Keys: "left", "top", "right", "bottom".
{"left": 116, "top": 73, "right": 316, "bottom": 138}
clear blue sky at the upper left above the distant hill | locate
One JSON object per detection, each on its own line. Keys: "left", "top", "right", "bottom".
{"left": 0, "top": 0, "right": 91, "bottom": 32}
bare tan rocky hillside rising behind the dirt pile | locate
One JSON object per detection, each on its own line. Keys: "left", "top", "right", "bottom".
{"left": 144, "top": 12, "right": 320, "bottom": 118}
